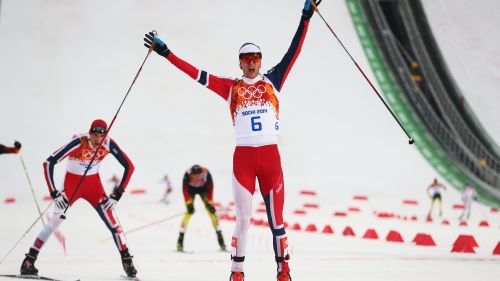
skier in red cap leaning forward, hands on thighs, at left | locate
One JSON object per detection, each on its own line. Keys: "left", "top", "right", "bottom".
{"left": 21, "top": 119, "right": 137, "bottom": 277}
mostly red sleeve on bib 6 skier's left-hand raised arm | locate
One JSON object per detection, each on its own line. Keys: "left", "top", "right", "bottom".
{"left": 167, "top": 52, "right": 234, "bottom": 100}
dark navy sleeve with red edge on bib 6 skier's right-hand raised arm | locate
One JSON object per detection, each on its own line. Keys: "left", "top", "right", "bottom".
{"left": 265, "top": 17, "right": 309, "bottom": 91}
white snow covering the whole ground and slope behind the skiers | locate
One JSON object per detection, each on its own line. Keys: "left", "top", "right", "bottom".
{"left": 0, "top": 0, "right": 500, "bottom": 281}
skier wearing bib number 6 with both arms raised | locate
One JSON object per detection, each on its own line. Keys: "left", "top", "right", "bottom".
{"left": 144, "top": 0, "right": 321, "bottom": 281}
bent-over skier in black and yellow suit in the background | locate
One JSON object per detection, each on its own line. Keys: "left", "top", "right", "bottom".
{"left": 177, "top": 165, "right": 226, "bottom": 252}
